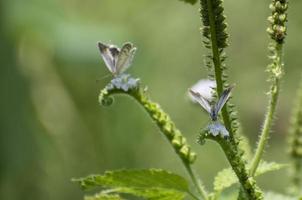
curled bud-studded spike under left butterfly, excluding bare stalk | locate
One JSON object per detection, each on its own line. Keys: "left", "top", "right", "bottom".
{"left": 99, "top": 86, "right": 196, "bottom": 163}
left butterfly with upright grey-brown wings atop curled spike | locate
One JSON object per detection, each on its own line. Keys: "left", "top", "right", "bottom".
{"left": 98, "top": 42, "right": 136, "bottom": 76}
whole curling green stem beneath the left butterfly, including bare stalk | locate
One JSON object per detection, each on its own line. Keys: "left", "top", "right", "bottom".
{"left": 99, "top": 88, "right": 208, "bottom": 200}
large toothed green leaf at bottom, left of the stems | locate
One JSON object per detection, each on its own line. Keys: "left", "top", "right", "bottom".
{"left": 73, "top": 169, "right": 189, "bottom": 200}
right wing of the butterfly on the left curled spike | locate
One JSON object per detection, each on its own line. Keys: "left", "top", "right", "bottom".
{"left": 116, "top": 42, "right": 136, "bottom": 74}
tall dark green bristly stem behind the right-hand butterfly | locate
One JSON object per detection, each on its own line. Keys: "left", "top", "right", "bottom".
{"left": 201, "top": 0, "right": 263, "bottom": 200}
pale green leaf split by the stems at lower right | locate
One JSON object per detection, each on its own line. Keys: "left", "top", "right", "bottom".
{"left": 214, "top": 161, "right": 287, "bottom": 194}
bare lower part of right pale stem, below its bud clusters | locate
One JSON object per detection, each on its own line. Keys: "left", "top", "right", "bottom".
{"left": 250, "top": 43, "right": 283, "bottom": 176}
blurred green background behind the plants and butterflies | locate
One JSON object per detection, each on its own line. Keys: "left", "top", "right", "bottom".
{"left": 0, "top": 0, "right": 302, "bottom": 200}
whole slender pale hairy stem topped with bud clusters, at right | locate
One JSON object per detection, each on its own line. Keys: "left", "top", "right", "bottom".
{"left": 250, "top": 0, "right": 288, "bottom": 176}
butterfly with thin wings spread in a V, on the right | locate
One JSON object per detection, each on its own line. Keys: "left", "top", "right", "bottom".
{"left": 190, "top": 85, "right": 234, "bottom": 121}
